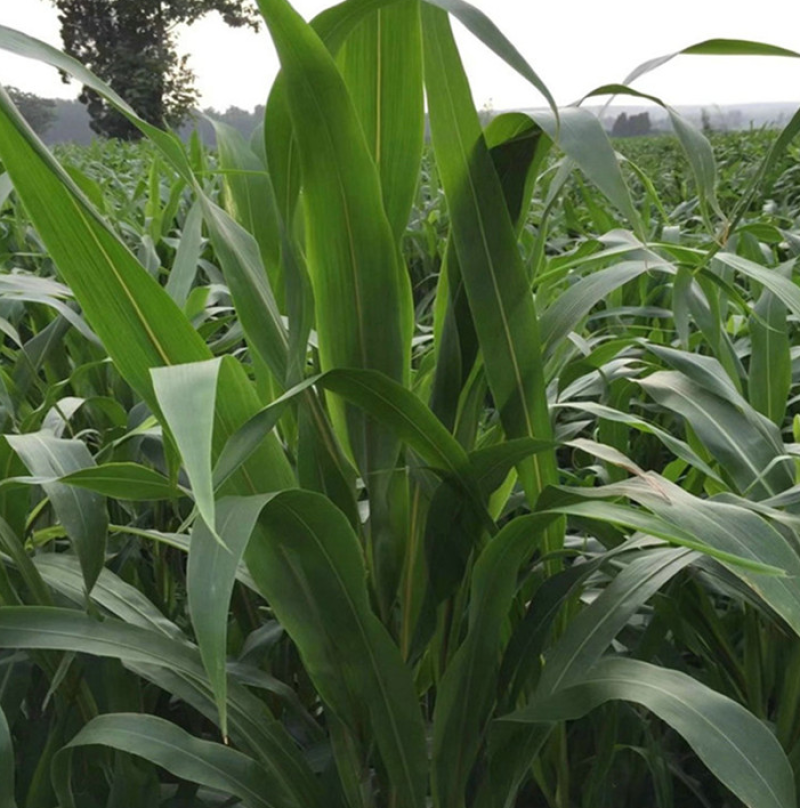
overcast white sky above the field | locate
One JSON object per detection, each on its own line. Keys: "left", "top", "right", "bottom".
{"left": 0, "top": 0, "right": 800, "bottom": 110}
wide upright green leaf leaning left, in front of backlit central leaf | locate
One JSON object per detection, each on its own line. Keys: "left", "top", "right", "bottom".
{"left": 259, "top": 0, "right": 412, "bottom": 482}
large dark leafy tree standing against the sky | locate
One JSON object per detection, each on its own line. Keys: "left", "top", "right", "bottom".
{"left": 52, "top": 0, "right": 258, "bottom": 140}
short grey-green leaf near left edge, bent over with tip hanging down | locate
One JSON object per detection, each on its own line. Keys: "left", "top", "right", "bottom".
{"left": 6, "top": 432, "right": 108, "bottom": 592}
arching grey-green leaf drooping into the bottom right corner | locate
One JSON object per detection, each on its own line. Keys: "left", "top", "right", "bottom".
{"left": 500, "top": 657, "right": 797, "bottom": 808}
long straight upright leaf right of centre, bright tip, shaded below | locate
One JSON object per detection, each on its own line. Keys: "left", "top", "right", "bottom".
{"left": 423, "top": 7, "right": 555, "bottom": 512}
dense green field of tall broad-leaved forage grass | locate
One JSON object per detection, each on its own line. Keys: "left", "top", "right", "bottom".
{"left": 0, "top": 0, "right": 800, "bottom": 808}
